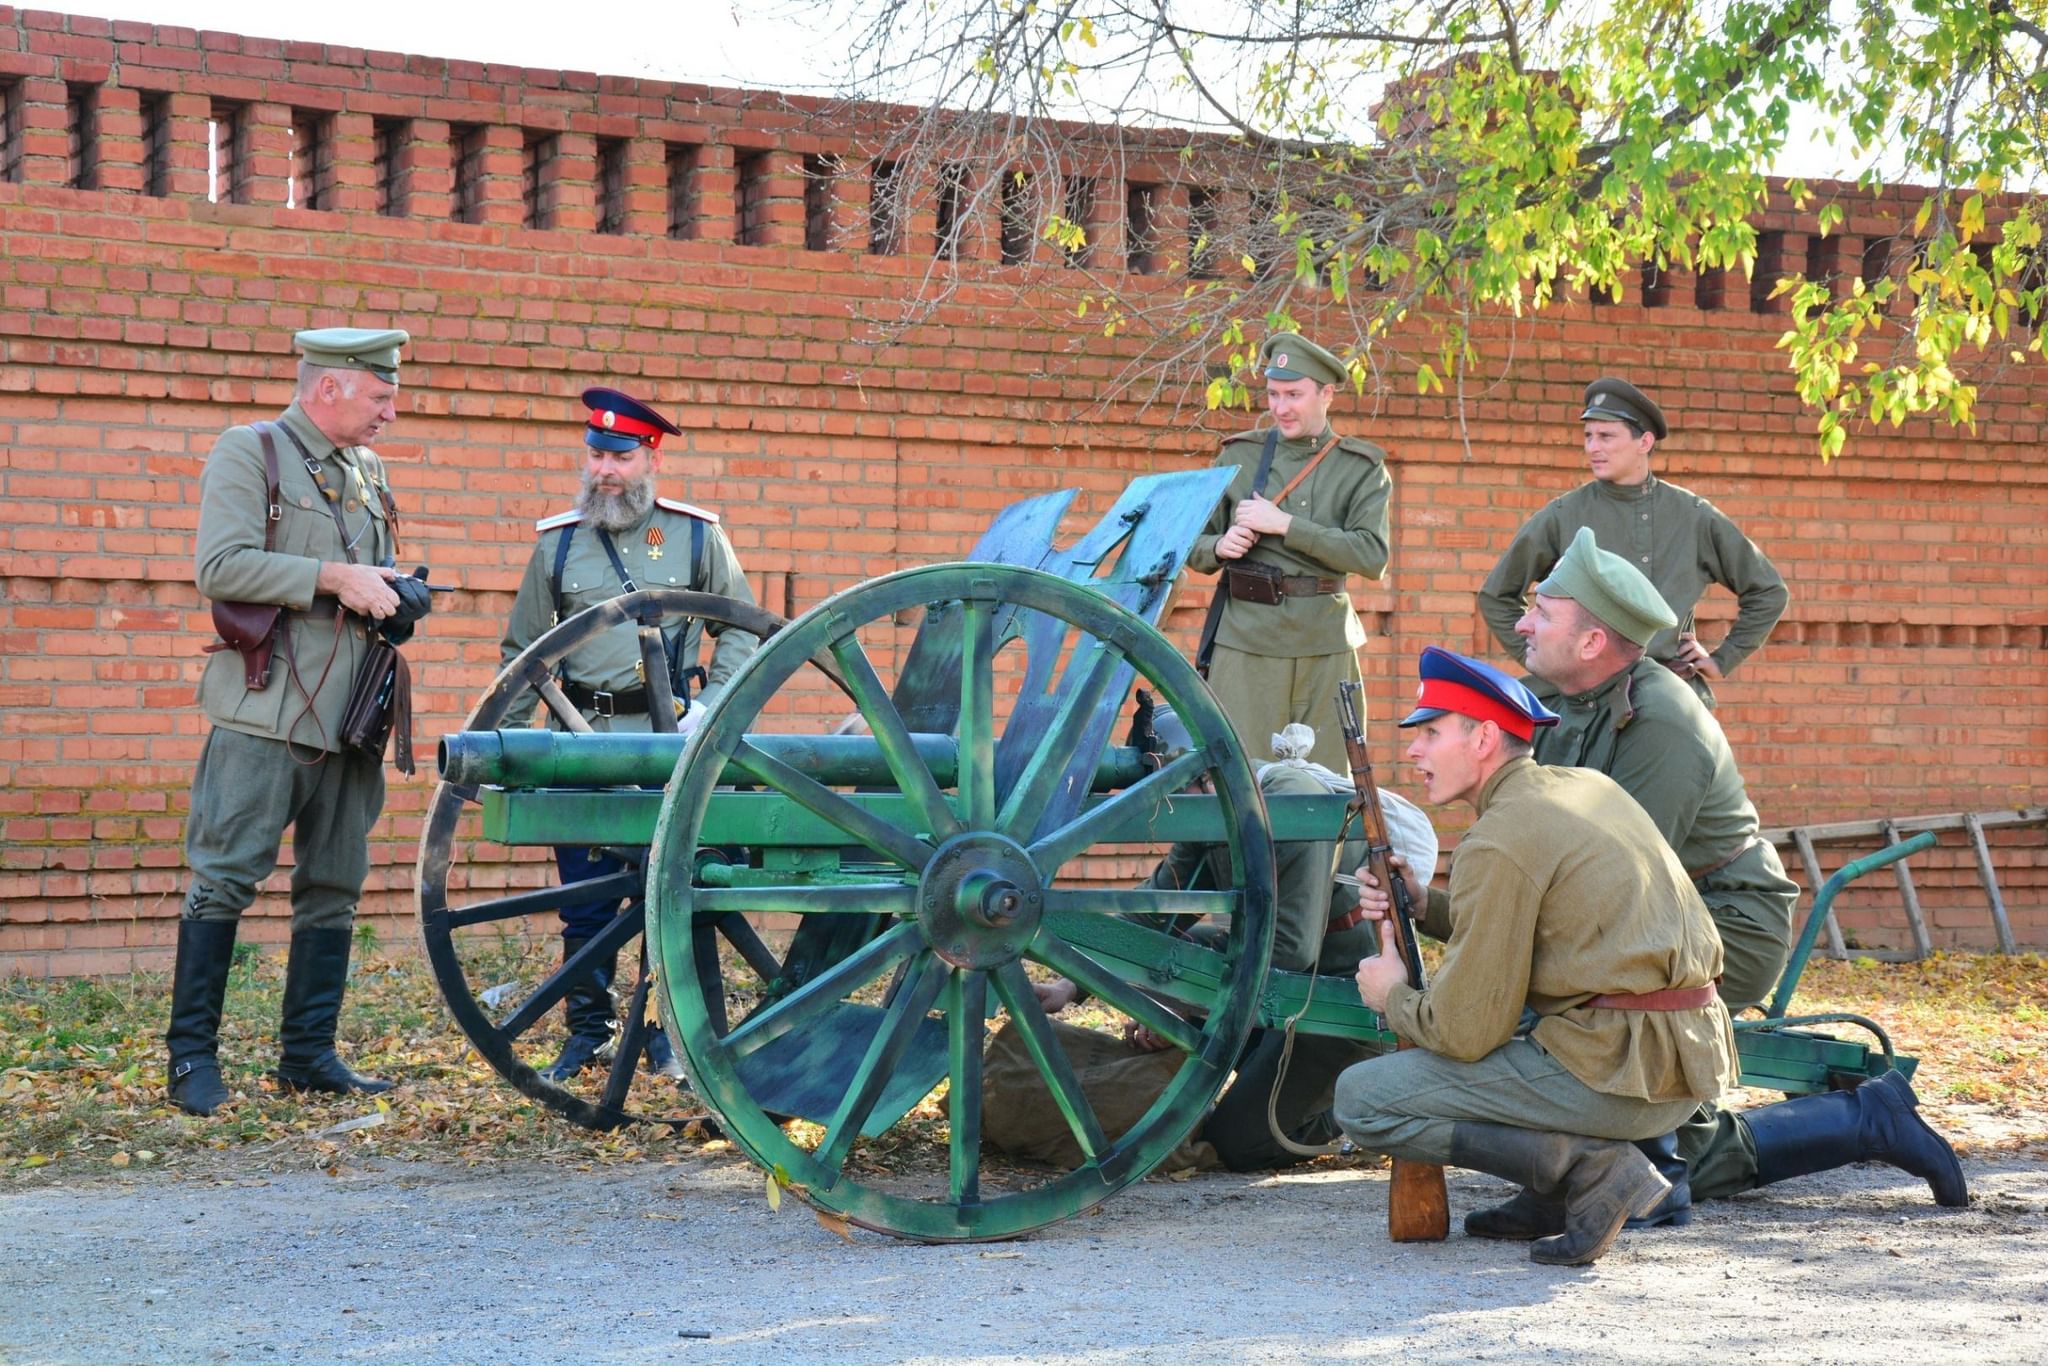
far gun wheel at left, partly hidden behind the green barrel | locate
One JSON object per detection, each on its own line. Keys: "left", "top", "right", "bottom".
{"left": 414, "top": 588, "right": 784, "bottom": 1130}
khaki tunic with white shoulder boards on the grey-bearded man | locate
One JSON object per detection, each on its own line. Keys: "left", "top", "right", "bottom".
{"left": 498, "top": 502, "right": 760, "bottom": 731}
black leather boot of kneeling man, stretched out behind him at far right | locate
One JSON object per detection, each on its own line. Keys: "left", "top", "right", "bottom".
{"left": 1743, "top": 1071, "right": 1970, "bottom": 1208}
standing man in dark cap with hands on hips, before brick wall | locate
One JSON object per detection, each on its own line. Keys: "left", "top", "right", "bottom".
{"left": 1479, "top": 377, "right": 1790, "bottom": 707}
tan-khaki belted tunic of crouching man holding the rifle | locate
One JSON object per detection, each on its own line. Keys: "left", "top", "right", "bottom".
{"left": 1386, "top": 758, "right": 1735, "bottom": 1102}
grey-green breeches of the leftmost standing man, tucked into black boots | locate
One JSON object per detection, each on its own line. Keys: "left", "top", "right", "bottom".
{"left": 184, "top": 727, "right": 385, "bottom": 934}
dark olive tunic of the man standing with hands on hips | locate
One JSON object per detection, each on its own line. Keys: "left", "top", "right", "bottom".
{"left": 1479, "top": 475, "right": 1790, "bottom": 674}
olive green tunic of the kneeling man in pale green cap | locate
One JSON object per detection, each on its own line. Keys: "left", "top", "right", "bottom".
{"left": 1536, "top": 657, "right": 1798, "bottom": 1012}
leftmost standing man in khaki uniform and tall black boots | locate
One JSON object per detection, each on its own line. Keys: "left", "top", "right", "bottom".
{"left": 164, "top": 328, "right": 430, "bottom": 1114}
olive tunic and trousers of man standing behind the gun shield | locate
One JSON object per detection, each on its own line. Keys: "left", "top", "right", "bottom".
{"left": 1188, "top": 428, "right": 1395, "bottom": 770}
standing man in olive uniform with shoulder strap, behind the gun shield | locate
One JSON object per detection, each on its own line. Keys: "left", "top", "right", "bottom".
{"left": 1188, "top": 332, "right": 1395, "bottom": 770}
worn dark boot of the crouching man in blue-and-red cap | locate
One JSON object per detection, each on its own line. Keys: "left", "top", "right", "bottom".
{"left": 1450, "top": 1122, "right": 1671, "bottom": 1266}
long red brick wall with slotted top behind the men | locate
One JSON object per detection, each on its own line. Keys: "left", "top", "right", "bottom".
{"left": 0, "top": 6, "right": 2048, "bottom": 973}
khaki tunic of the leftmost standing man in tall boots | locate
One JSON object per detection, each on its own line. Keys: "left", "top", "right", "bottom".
{"left": 193, "top": 403, "right": 395, "bottom": 750}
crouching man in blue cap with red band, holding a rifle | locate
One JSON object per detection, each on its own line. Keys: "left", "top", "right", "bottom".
{"left": 1335, "top": 647, "right": 1735, "bottom": 1266}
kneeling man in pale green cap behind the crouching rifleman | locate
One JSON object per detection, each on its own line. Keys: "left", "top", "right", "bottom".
{"left": 1515, "top": 530, "right": 1968, "bottom": 1239}
